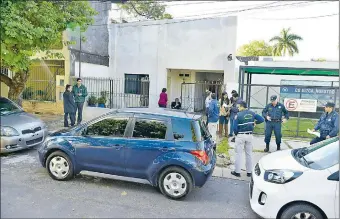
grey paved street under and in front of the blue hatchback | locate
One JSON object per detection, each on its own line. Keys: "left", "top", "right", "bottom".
{"left": 1, "top": 150, "right": 256, "bottom": 218}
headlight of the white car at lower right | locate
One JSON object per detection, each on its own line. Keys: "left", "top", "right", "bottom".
{"left": 264, "top": 170, "right": 302, "bottom": 184}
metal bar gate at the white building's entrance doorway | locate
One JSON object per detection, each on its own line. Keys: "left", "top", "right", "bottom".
{"left": 181, "top": 81, "right": 223, "bottom": 112}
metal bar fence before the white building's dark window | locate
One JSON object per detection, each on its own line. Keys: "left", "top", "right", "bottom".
{"left": 70, "top": 77, "right": 150, "bottom": 109}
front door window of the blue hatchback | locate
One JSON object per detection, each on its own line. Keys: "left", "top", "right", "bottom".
{"left": 84, "top": 118, "right": 129, "bottom": 137}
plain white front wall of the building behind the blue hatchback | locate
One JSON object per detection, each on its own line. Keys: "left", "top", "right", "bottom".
{"left": 109, "top": 17, "right": 237, "bottom": 107}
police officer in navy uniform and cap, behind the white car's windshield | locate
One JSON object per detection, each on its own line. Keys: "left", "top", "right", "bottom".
{"left": 310, "top": 102, "right": 339, "bottom": 144}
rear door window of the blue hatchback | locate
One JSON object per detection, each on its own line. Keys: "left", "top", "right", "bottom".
{"left": 132, "top": 119, "right": 167, "bottom": 139}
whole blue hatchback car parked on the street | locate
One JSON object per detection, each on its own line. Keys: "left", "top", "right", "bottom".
{"left": 38, "top": 109, "right": 216, "bottom": 199}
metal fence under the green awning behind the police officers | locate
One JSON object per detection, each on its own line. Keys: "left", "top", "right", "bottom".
{"left": 240, "top": 84, "right": 340, "bottom": 138}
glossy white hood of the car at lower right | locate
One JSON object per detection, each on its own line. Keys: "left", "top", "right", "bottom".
{"left": 259, "top": 150, "right": 308, "bottom": 171}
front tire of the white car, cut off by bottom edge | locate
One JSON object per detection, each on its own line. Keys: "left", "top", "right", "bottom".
{"left": 280, "top": 203, "right": 324, "bottom": 219}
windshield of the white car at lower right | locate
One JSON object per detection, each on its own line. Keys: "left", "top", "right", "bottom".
{"left": 296, "top": 137, "right": 339, "bottom": 170}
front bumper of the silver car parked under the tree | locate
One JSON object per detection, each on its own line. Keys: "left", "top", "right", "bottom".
{"left": 1, "top": 129, "right": 48, "bottom": 153}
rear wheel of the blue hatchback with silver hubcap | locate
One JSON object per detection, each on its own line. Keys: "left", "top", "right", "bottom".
{"left": 158, "top": 167, "right": 193, "bottom": 200}
